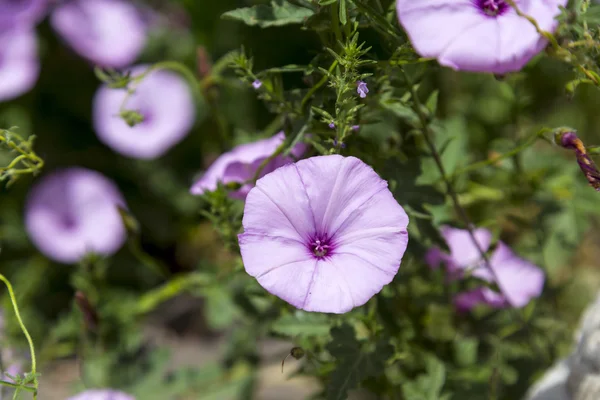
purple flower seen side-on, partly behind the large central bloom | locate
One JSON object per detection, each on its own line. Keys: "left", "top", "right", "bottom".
{"left": 190, "top": 132, "right": 306, "bottom": 200}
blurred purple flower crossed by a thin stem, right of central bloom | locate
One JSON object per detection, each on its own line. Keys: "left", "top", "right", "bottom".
{"left": 425, "top": 226, "right": 544, "bottom": 310}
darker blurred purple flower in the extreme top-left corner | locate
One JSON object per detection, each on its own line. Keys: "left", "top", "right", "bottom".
{"left": 0, "top": 0, "right": 48, "bottom": 32}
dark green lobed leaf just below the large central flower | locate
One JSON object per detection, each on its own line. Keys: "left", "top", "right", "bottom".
{"left": 327, "top": 324, "right": 394, "bottom": 400}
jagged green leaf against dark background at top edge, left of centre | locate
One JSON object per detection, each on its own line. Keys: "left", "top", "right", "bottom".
{"left": 221, "top": 0, "right": 314, "bottom": 28}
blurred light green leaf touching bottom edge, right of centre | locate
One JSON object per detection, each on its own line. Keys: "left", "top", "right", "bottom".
{"left": 402, "top": 356, "right": 447, "bottom": 400}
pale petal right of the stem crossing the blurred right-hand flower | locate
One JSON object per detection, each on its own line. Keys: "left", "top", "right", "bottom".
{"left": 490, "top": 242, "right": 545, "bottom": 308}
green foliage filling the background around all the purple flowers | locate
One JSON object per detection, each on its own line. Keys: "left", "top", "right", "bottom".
{"left": 0, "top": 0, "right": 600, "bottom": 400}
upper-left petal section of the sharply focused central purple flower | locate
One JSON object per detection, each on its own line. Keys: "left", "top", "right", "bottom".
{"left": 242, "top": 164, "right": 315, "bottom": 242}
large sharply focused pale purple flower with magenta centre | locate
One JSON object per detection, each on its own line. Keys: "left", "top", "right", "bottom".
{"left": 239, "top": 155, "right": 408, "bottom": 314}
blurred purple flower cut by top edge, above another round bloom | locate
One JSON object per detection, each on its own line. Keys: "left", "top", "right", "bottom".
{"left": 50, "top": 0, "right": 146, "bottom": 68}
